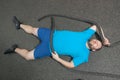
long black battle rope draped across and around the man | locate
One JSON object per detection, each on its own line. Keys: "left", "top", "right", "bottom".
{"left": 38, "top": 14, "right": 120, "bottom": 79}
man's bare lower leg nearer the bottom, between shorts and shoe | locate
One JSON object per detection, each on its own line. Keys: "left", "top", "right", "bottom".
{"left": 15, "top": 48, "right": 34, "bottom": 60}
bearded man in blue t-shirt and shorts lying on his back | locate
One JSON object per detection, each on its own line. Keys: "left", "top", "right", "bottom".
{"left": 4, "top": 16, "right": 110, "bottom": 68}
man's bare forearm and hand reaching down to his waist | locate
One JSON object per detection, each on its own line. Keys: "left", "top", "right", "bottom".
{"left": 52, "top": 52, "right": 74, "bottom": 68}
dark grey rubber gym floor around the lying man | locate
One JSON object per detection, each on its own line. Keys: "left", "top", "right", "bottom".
{"left": 0, "top": 0, "right": 120, "bottom": 80}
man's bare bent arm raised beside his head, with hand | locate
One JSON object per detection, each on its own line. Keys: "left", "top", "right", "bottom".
{"left": 91, "top": 25, "right": 110, "bottom": 46}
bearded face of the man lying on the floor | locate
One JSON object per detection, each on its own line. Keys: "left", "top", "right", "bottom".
{"left": 89, "top": 39, "right": 102, "bottom": 51}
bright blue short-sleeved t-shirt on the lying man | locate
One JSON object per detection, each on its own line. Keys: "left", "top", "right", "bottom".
{"left": 53, "top": 28, "right": 95, "bottom": 66}
